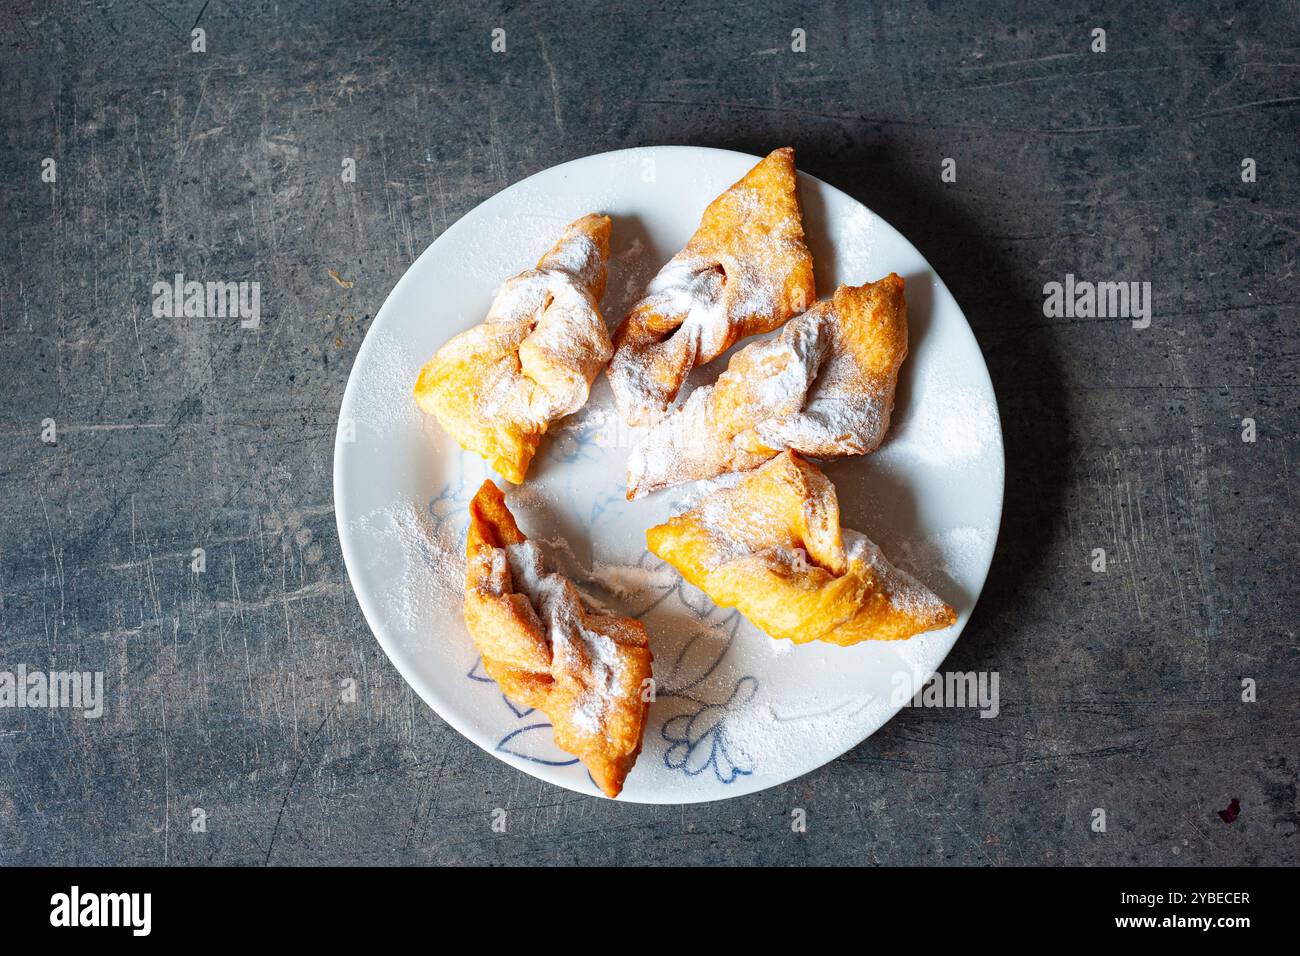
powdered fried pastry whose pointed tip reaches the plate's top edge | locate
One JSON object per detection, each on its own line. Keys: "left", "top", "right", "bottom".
{"left": 608, "top": 147, "right": 816, "bottom": 425}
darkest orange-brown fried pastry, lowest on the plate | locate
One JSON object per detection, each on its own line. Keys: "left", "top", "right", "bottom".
{"left": 465, "top": 481, "right": 651, "bottom": 797}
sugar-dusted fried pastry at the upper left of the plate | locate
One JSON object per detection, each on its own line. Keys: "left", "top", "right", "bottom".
{"left": 415, "top": 215, "right": 614, "bottom": 485}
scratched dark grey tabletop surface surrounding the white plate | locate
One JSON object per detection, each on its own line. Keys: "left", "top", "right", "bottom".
{"left": 0, "top": 0, "right": 1300, "bottom": 865}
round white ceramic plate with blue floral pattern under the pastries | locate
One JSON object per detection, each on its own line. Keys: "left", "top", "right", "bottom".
{"left": 334, "top": 146, "right": 1004, "bottom": 804}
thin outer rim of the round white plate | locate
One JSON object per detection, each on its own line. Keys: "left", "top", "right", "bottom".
{"left": 330, "top": 144, "right": 1006, "bottom": 806}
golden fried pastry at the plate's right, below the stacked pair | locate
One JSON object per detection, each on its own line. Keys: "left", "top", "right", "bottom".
{"left": 646, "top": 451, "right": 957, "bottom": 646}
